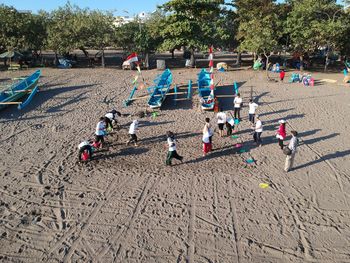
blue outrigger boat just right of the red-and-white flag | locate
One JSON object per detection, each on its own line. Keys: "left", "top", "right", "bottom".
{"left": 147, "top": 69, "right": 173, "bottom": 109}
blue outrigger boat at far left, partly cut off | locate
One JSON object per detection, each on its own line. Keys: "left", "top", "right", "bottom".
{"left": 0, "top": 70, "right": 41, "bottom": 110}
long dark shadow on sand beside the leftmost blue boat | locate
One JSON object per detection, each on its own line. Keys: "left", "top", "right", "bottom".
{"left": 0, "top": 84, "right": 98, "bottom": 120}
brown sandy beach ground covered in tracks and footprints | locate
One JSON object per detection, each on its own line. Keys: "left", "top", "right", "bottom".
{"left": 0, "top": 66, "right": 350, "bottom": 263}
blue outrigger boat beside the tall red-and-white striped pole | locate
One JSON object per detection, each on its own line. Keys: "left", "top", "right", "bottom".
{"left": 198, "top": 69, "right": 215, "bottom": 110}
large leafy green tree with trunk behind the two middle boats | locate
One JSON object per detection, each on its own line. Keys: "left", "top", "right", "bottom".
{"left": 161, "top": 0, "right": 224, "bottom": 66}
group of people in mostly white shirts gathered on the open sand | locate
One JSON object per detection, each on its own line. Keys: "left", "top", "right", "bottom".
{"left": 78, "top": 93, "right": 298, "bottom": 172}
